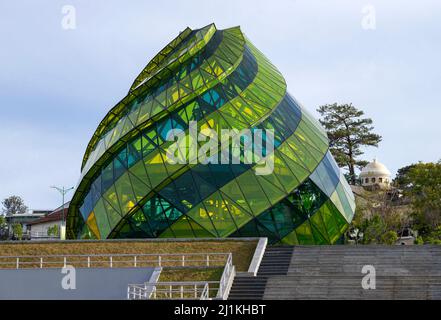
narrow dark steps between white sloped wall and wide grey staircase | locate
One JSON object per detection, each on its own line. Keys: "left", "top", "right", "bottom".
{"left": 228, "top": 246, "right": 293, "bottom": 300}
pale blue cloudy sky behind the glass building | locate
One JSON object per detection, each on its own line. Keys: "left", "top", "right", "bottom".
{"left": 0, "top": 0, "right": 441, "bottom": 209}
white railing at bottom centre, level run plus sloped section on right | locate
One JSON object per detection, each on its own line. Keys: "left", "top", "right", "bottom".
{"left": 127, "top": 253, "right": 235, "bottom": 300}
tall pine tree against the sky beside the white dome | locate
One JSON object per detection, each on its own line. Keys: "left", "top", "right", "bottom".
{"left": 317, "top": 103, "right": 382, "bottom": 184}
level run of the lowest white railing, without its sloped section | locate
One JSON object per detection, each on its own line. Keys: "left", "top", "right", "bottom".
{"left": 127, "top": 281, "right": 219, "bottom": 300}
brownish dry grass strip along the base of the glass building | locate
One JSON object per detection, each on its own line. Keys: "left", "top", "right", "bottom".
{"left": 0, "top": 240, "right": 257, "bottom": 271}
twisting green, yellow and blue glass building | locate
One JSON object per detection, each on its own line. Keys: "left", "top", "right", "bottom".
{"left": 67, "top": 24, "right": 355, "bottom": 244}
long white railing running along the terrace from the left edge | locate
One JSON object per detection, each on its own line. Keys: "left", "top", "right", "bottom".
{"left": 0, "top": 253, "right": 231, "bottom": 269}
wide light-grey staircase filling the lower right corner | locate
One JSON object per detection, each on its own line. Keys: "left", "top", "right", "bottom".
{"left": 264, "top": 246, "right": 441, "bottom": 299}
